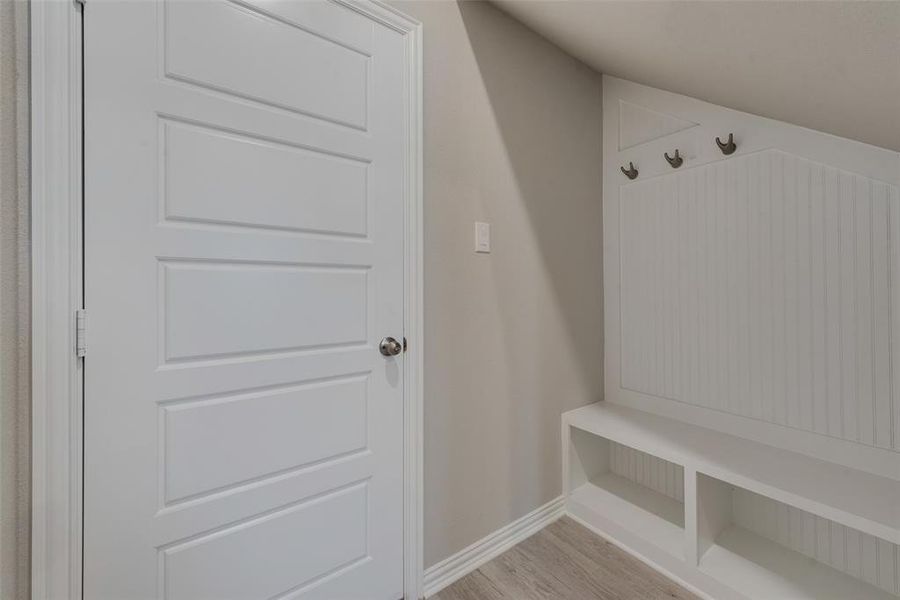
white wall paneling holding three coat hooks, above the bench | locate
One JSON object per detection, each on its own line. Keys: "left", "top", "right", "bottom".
{"left": 603, "top": 77, "right": 900, "bottom": 479}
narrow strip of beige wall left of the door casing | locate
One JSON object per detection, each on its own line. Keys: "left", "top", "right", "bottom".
{"left": 0, "top": 1, "right": 31, "bottom": 600}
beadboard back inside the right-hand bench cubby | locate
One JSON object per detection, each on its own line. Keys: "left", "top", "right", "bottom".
{"left": 732, "top": 488, "right": 900, "bottom": 596}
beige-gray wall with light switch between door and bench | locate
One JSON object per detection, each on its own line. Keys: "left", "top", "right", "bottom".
{"left": 392, "top": 1, "right": 603, "bottom": 567}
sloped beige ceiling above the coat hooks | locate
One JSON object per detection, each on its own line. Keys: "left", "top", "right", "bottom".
{"left": 492, "top": 0, "right": 900, "bottom": 151}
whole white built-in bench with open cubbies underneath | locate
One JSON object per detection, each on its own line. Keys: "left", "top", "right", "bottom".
{"left": 562, "top": 402, "right": 900, "bottom": 600}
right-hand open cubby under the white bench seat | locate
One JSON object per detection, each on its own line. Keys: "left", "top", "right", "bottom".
{"left": 697, "top": 473, "right": 900, "bottom": 600}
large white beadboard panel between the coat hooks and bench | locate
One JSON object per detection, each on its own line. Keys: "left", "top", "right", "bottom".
{"left": 619, "top": 149, "right": 900, "bottom": 451}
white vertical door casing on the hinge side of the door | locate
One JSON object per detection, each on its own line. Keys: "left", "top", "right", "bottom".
{"left": 31, "top": 0, "right": 82, "bottom": 600}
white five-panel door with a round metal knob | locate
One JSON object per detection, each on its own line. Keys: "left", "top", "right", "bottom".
{"left": 83, "top": 0, "right": 407, "bottom": 600}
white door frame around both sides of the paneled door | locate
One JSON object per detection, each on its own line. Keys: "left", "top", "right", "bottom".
{"left": 31, "top": 0, "right": 424, "bottom": 600}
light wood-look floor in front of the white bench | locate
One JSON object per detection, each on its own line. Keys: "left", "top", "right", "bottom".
{"left": 429, "top": 517, "right": 697, "bottom": 600}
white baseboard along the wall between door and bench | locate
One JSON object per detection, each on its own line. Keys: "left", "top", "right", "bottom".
{"left": 424, "top": 496, "right": 565, "bottom": 598}
